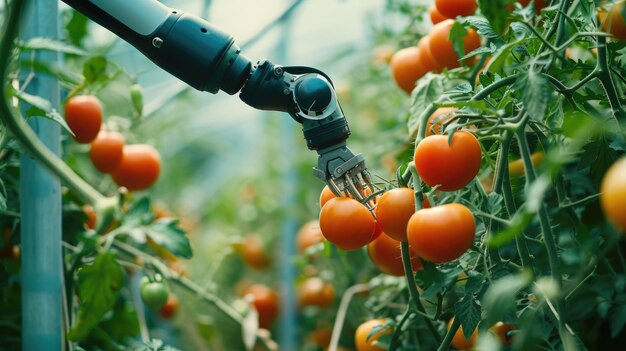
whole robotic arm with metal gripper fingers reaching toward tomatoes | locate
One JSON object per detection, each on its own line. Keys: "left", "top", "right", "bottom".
{"left": 63, "top": 0, "right": 374, "bottom": 205}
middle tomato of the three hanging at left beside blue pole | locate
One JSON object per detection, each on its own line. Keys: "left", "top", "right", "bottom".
{"left": 89, "top": 130, "right": 125, "bottom": 173}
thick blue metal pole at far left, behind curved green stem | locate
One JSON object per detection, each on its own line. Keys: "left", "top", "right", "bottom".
{"left": 20, "top": 0, "right": 63, "bottom": 351}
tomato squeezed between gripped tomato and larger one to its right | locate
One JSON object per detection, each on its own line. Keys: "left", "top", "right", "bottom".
{"left": 376, "top": 188, "right": 415, "bottom": 241}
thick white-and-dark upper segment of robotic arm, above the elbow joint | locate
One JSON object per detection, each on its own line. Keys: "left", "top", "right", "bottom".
{"left": 63, "top": 0, "right": 251, "bottom": 95}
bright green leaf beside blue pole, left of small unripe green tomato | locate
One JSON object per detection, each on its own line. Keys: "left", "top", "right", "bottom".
{"left": 67, "top": 252, "right": 123, "bottom": 341}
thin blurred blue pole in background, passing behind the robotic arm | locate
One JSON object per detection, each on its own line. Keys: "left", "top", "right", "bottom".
{"left": 276, "top": 6, "right": 298, "bottom": 350}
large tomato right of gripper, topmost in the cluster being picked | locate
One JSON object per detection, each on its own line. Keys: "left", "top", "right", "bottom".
{"left": 414, "top": 130, "right": 481, "bottom": 191}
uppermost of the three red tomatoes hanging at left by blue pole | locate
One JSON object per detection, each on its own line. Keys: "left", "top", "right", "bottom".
{"left": 65, "top": 95, "right": 102, "bottom": 144}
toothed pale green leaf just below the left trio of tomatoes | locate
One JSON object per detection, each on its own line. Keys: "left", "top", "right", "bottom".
{"left": 146, "top": 218, "right": 193, "bottom": 258}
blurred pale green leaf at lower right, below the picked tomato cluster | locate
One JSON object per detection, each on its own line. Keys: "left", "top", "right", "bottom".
{"left": 482, "top": 271, "right": 533, "bottom": 326}
